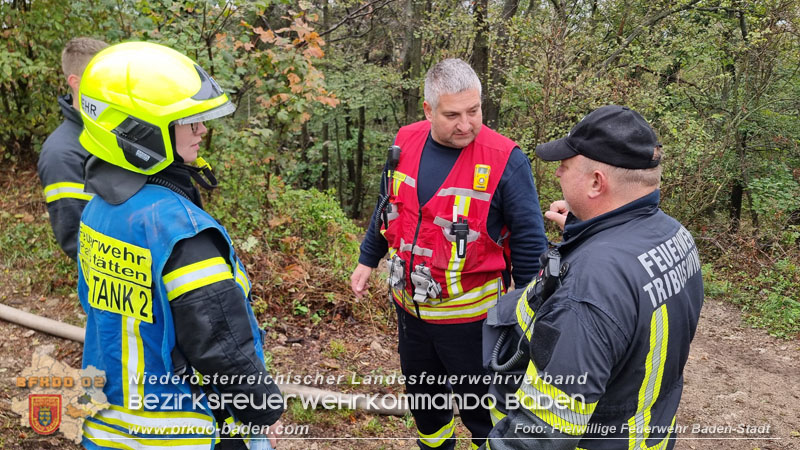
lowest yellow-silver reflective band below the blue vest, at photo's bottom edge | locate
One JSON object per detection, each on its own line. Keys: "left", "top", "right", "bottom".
{"left": 83, "top": 420, "right": 214, "bottom": 450}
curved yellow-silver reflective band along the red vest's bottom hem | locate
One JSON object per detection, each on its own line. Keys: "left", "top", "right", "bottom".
{"left": 392, "top": 278, "right": 502, "bottom": 321}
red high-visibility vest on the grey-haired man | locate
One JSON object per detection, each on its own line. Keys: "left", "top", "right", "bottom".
{"left": 382, "top": 120, "right": 517, "bottom": 324}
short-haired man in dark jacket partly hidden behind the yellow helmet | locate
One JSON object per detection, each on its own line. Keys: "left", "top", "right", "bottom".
{"left": 37, "top": 37, "right": 108, "bottom": 260}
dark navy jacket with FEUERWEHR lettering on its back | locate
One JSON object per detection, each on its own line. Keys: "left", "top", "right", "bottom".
{"left": 486, "top": 191, "right": 703, "bottom": 449}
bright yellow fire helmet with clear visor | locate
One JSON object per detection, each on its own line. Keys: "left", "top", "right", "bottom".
{"left": 80, "top": 42, "right": 236, "bottom": 175}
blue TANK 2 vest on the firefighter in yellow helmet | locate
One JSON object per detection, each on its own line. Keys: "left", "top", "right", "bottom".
{"left": 78, "top": 185, "right": 266, "bottom": 449}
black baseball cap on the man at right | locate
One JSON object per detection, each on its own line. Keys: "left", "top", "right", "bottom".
{"left": 536, "top": 105, "right": 661, "bottom": 169}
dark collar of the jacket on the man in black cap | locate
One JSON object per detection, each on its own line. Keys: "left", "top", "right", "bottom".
{"left": 558, "top": 189, "right": 661, "bottom": 248}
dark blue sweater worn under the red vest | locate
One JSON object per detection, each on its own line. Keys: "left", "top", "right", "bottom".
{"left": 358, "top": 135, "right": 547, "bottom": 287}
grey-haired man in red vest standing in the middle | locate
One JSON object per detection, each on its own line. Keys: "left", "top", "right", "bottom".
{"left": 351, "top": 59, "right": 547, "bottom": 450}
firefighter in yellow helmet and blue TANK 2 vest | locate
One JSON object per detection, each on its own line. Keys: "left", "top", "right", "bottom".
{"left": 78, "top": 42, "right": 283, "bottom": 449}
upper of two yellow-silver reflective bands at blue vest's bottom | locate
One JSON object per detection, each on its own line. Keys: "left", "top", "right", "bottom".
{"left": 94, "top": 398, "right": 216, "bottom": 435}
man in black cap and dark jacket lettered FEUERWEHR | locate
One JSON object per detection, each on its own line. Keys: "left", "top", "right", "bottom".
{"left": 485, "top": 105, "right": 703, "bottom": 450}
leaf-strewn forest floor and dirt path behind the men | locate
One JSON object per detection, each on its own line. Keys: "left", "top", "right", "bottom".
{"left": 0, "top": 284, "right": 800, "bottom": 450}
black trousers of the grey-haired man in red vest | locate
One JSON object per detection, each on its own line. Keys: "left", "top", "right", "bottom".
{"left": 395, "top": 304, "right": 492, "bottom": 450}
